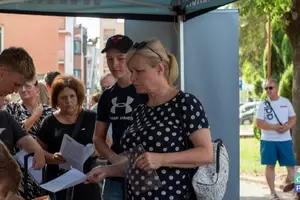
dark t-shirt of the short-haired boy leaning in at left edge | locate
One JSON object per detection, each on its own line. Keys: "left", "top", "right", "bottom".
{"left": 0, "top": 111, "right": 27, "bottom": 154}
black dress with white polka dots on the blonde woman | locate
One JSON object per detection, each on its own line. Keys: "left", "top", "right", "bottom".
{"left": 121, "top": 91, "right": 209, "bottom": 200}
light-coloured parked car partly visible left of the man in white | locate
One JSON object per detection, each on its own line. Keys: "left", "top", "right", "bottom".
{"left": 240, "top": 102, "right": 260, "bottom": 125}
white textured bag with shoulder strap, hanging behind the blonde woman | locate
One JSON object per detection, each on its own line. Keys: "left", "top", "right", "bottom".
{"left": 180, "top": 94, "right": 229, "bottom": 200}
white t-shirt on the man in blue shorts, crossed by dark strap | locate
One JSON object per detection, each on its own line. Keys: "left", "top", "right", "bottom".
{"left": 256, "top": 97, "right": 296, "bottom": 141}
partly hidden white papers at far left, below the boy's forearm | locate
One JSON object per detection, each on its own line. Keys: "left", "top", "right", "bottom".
{"left": 15, "top": 150, "right": 43, "bottom": 184}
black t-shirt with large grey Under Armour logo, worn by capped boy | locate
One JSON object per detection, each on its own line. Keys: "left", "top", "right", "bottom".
{"left": 97, "top": 83, "right": 146, "bottom": 154}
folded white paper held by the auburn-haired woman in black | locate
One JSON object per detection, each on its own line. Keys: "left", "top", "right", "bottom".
{"left": 59, "top": 134, "right": 95, "bottom": 172}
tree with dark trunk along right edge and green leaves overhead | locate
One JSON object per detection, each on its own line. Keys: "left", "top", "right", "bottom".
{"left": 241, "top": 0, "right": 300, "bottom": 165}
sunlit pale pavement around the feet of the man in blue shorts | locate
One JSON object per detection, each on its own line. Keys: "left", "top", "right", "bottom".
{"left": 240, "top": 181, "right": 294, "bottom": 200}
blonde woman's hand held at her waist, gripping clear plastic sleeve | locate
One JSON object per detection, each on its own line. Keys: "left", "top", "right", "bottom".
{"left": 135, "top": 152, "right": 164, "bottom": 171}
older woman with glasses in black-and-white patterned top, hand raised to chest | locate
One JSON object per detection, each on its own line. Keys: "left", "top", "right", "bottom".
{"left": 5, "top": 79, "right": 53, "bottom": 199}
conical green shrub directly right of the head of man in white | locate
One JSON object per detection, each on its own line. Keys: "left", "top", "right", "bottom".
{"left": 279, "top": 65, "right": 293, "bottom": 102}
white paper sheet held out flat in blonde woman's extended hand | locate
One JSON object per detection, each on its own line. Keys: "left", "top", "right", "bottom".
{"left": 40, "top": 169, "right": 87, "bottom": 193}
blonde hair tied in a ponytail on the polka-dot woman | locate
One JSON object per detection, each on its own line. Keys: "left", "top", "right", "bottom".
{"left": 127, "top": 39, "right": 178, "bottom": 85}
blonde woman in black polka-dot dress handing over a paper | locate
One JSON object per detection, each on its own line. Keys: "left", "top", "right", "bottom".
{"left": 88, "top": 40, "right": 213, "bottom": 200}
